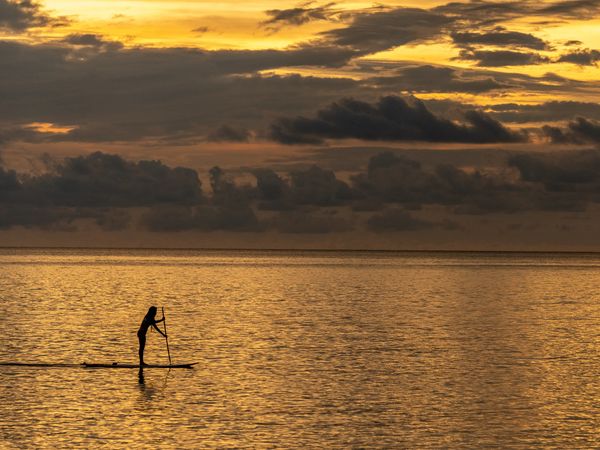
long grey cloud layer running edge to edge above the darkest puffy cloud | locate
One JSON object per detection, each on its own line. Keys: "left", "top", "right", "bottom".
{"left": 0, "top": 34, "right": 598, "bottom": 144}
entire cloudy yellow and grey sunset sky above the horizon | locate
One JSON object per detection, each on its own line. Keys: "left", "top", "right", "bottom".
{"left": 0, "top": 0, "right": 600, "bottom": 251}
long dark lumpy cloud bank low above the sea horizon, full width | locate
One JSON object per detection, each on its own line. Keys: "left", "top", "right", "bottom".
{"left": 0, "top": 150, "right": 600, "bottom": 233}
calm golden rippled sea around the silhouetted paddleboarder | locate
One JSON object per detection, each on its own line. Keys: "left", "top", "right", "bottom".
{"left": 0, "top": 250, "right": 600, "bottom": 449}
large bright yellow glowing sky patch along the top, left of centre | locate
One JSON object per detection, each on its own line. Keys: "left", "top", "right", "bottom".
{"left": 39, "top": 0, "right": 443, "bottom": 50}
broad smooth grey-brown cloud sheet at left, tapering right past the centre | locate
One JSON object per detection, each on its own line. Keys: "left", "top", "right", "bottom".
{"left": 0, "top": 40, "right": 365, "bottom": 142}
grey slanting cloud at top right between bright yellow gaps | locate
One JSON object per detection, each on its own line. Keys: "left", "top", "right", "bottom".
{"left": 294, "top": 0, "right": 600, "bottom": 54}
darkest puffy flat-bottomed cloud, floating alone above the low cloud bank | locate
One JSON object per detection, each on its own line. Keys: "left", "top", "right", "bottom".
{"left": 270, "top": 96, "right": 525, "bottom": 144}
